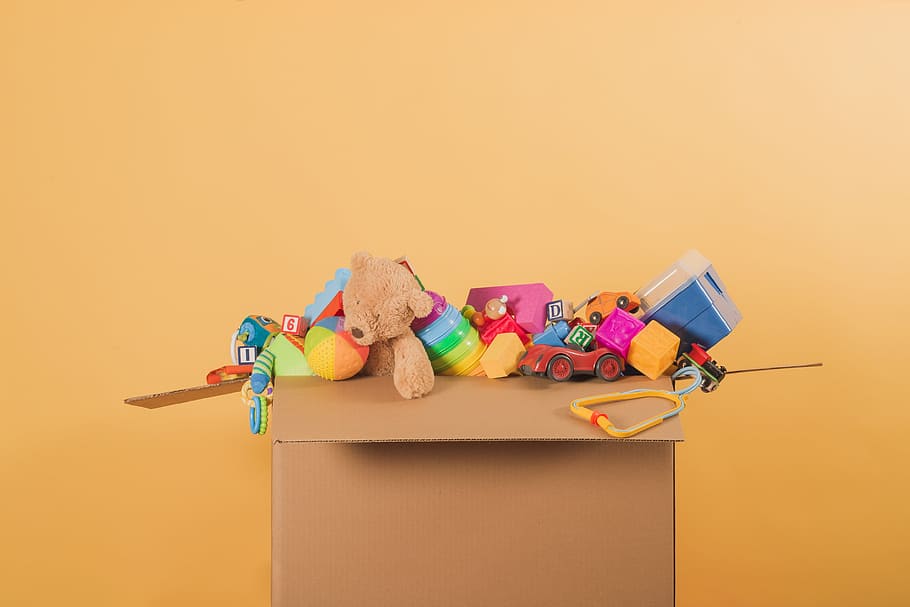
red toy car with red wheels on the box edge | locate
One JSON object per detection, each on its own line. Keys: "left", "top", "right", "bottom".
{"left": 518, "top": 344, "right": 626, "bottom": 381}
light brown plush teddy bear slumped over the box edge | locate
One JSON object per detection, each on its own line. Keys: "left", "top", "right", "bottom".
{"left": 342, "top": 252, "right": 435, "bottom": 398}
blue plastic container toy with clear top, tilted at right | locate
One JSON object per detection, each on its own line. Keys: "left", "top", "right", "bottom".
{"left": 635, "top": 249, "right": 742, "bottom": 348}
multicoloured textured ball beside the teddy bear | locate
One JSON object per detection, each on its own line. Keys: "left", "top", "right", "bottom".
{"left": 304, "top": 316, "right": 370, "bottom": 381}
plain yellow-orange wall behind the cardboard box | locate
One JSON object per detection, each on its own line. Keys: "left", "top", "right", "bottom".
{"left": 0, "top": 0, "right": 910, "bottom": 607}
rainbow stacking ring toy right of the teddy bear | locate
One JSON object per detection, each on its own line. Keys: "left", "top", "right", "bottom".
{"left": 411, "top": 291, "right": 486, "bottom": 375}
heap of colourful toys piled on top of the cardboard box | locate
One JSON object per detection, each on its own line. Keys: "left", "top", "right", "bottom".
{"left": 210, "top": 250, "right": 742, "bottom": 434}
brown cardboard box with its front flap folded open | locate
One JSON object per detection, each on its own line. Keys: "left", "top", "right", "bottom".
{"left": 271, "top": 377, "right": 683, "bottom": 607}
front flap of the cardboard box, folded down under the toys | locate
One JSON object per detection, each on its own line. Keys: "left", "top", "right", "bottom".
{"left": 270, "top": 376, "right": 683, "bottom": 443}
